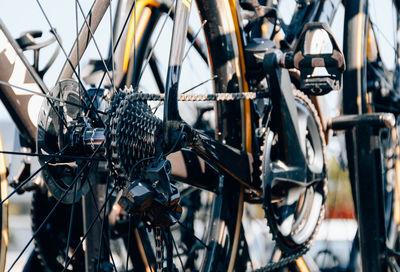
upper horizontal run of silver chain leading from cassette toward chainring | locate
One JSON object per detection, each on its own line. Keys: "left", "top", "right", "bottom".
{"left": 115, "top": 89, "right": 268, "bottom": 101}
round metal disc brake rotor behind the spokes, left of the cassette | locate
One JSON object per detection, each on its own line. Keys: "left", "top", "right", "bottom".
{"left": 37, "top": 80, "right": 99, "bottom": 203}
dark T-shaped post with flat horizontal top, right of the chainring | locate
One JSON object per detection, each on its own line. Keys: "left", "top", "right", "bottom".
{"left": 328, "top": 113, "right": 395, "bottom": 272}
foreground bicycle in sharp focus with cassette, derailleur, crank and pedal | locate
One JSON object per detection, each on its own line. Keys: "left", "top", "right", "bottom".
{"left": 0, "top": 1, "right": 344, "bottom": 271}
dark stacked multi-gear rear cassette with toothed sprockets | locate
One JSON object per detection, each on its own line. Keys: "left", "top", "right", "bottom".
{"left": 105, "top": 92, "right": 162, "bottom": 184}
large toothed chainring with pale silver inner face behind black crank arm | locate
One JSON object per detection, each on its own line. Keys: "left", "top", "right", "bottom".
{"left": 261, "top": 91, "right": 327, "bottom": 256}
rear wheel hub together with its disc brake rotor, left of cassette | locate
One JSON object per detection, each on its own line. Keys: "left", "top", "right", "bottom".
{"left": 37, "top": 80, "right": 105, "bottom": 203}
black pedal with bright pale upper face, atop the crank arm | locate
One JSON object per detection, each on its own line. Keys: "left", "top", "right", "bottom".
{"left": 283, "top": 22, "right": 346, "bottom": 95}
